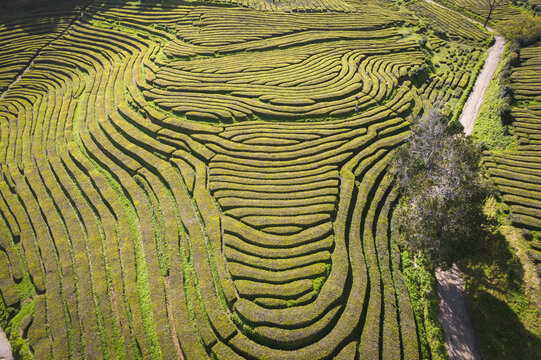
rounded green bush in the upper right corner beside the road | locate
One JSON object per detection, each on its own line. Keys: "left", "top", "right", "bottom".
{"left": 496, "top": 13, "right": 541, "bottom": 46}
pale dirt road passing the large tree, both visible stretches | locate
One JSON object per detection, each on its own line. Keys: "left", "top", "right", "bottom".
{"left": 425, "top": 0, "right": 505, "bottom": 360}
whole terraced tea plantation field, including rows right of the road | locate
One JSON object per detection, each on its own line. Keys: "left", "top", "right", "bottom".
{"left": 0, "top": 0, "right": 496, "bottom": 359}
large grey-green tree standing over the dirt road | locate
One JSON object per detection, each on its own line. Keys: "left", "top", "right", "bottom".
{"left": 391, "top": 109, "right": 489, "bottom": 268}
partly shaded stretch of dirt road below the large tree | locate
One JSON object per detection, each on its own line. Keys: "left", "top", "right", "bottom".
{"left": 436, "top": 264, "right": 482, "bottom": 360}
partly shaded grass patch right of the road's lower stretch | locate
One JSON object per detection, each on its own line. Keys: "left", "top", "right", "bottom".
{"left": 461, "top": 199, "right": 541, "bottom": 359}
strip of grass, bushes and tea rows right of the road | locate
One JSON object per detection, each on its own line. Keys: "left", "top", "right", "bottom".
{"left": 466, "top": 9, "right": 541, "bottom": 359}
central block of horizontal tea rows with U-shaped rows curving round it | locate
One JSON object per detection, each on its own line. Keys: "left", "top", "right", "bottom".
{"left": 181, "top": 102, "right": 418, "bottom": 359}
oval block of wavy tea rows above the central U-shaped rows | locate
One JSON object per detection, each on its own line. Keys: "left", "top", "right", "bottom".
{"left": 144, "top": 46, "right": 420, "bottom": 121}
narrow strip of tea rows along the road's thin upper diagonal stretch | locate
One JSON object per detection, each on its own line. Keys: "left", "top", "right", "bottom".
{"left": 408, "top": 0, "right": 491, "bottom": 46}
